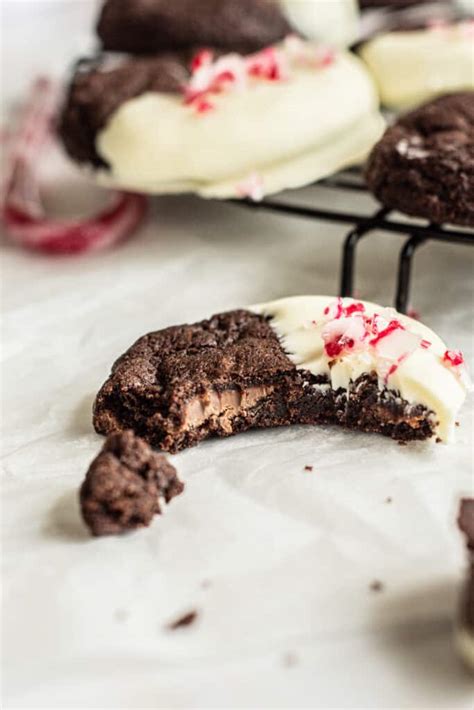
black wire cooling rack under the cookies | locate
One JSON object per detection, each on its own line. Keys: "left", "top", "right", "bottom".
{"left": 232, "top": 168, "right": 474, "bottom": 313}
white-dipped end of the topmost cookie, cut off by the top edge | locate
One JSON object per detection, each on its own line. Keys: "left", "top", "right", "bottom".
{"left": 279, "top": 0, "right": 359, "bottom": 47}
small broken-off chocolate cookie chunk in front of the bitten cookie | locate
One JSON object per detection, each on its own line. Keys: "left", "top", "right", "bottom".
{"left": 80, "top": 431, "right": 184, "bottom": 536}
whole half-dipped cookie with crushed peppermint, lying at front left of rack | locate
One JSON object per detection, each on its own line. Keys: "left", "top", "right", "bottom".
{"left": 59, "top": 42, "right": 384, "bottom": 200}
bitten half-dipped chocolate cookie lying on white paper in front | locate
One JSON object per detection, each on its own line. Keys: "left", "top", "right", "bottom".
{"left": 90, "top": 296, "right": 466, "bottom": 452}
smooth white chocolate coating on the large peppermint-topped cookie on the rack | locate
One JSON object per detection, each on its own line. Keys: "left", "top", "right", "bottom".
{"left": 96, "top": 45, "right": 384, "bottom": 198}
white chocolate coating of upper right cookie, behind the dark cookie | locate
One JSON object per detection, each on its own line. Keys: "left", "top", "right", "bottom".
{"left": 360, "top": 23, "right": 474, "bottom": 109}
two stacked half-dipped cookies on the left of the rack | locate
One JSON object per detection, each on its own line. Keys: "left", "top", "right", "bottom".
{"left": 60, "top": 0, "right": 384, "bottom": 199}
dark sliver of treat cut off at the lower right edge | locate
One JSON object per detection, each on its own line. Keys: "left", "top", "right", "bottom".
{"left": 456, "top": 498, "right": 474, "bottom": 672}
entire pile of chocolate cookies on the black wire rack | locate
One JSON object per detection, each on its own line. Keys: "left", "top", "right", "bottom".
{"left": 60, "top": 0, "right": 474, "bottom": 226}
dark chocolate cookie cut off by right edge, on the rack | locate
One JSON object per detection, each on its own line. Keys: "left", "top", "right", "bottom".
{"left": 366, "top": 92, "right": 474, "bottom": 227}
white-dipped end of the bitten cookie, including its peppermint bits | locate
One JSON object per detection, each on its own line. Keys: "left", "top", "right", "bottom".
{"left": 252, "top": 296, "right": 470, "bottom": 440}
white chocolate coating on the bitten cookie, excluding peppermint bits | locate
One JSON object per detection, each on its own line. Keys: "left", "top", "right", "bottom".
{"left": 251, "top": 296, "right": 467, "bottom": 440}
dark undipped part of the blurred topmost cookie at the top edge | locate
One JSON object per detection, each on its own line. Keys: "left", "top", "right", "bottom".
{"left": 97, "top": 0, "right": 293, "bottom": 54}
